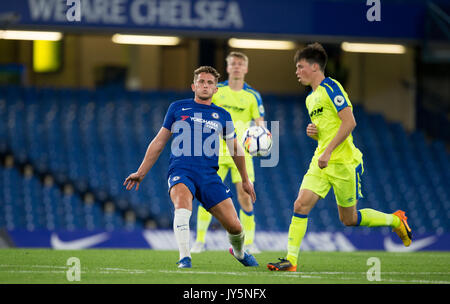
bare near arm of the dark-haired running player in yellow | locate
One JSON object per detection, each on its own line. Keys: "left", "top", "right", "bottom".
{"left": 318, "top": 106, "right": 356, "bottom": 169}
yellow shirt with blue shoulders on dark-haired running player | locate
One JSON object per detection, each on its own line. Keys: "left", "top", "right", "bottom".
{"left": 306, "top": 77, "right": 362, "bottom": 163}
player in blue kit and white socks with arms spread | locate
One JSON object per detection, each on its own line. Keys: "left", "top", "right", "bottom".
{"left": 124, "top": 66, "right": 258, "bottom": 268}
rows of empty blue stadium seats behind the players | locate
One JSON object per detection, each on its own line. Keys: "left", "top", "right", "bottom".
{"left": 0, "top": 86, "right": 450, "bottom": 233}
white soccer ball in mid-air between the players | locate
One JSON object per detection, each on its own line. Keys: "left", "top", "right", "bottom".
{"left": 243, "top": 126, "right": 272, "bottom": 156}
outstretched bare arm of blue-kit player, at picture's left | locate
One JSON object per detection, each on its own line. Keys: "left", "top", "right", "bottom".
{"left": 123, "top": 127, "right": 172, "bottom": 191}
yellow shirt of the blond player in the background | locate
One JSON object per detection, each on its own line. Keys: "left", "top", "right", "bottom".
{"left": 212, "top": 81, "right": 264, "bottom": 161}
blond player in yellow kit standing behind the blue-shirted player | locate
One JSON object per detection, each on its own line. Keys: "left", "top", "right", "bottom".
{"left": 191, "top": 52, "right": 264, "bottom": 254}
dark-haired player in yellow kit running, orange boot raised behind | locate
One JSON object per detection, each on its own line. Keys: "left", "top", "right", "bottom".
{"left": 267, "top": 43, "right": 411, "bottom": 271}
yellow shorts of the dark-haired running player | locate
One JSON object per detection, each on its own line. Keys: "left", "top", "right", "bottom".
{"left": 300, "top": 159, "right": 364, "bottom": 207}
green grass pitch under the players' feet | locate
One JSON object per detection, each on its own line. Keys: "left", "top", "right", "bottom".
{"left": 0, "top": 249, "right": 450, "bottom": 284}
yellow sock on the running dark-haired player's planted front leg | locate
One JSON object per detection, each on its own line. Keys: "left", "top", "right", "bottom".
{"left": 286, "top": 213, "right": 308, "bottom": 266}
